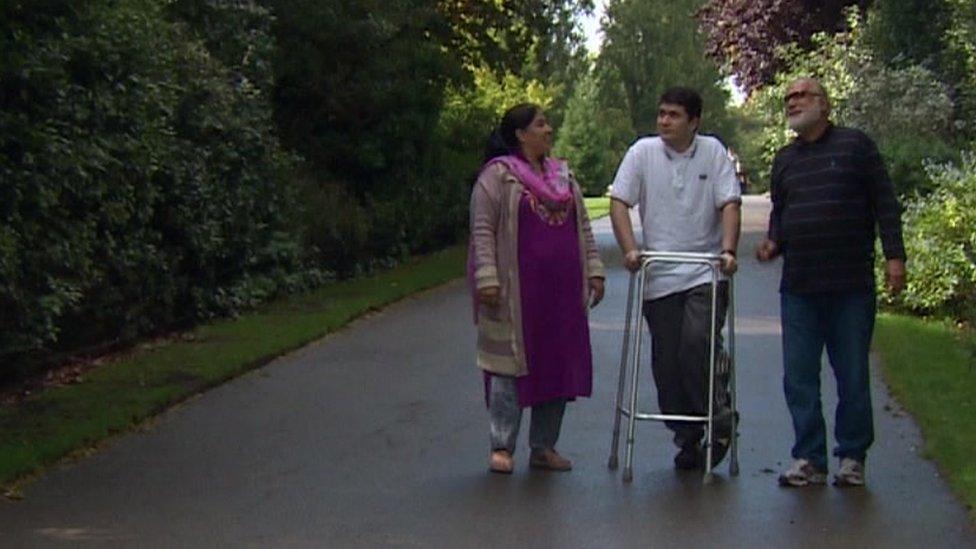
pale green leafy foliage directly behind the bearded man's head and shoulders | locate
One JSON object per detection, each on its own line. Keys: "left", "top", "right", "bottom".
{"left": 748, "top": 11, "right": 957, "bottom": 193}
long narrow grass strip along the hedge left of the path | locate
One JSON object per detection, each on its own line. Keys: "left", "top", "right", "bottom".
{"left": 0, "top": 246, "right": 466, "bottom": 488}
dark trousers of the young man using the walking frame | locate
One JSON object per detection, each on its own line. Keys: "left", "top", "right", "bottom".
{"left": 644, "top": 282, "right": 729, "bottom": 447}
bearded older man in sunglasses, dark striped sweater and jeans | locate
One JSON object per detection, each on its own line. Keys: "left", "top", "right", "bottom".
{"left": 756, "top": 78, "right": 905, "bottom": 486}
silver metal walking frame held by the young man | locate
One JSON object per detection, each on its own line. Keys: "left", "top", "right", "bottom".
{"left": 607, "top": 251, "right": 739, "bottom": 484}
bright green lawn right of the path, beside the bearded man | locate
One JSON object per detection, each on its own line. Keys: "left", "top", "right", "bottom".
{"left": 874, "top": 314, "right": 976, "bottom": 518}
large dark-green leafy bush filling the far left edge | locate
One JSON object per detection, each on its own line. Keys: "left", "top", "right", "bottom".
{"left": 0, "top": 0, "right": 304, "bottom": 377}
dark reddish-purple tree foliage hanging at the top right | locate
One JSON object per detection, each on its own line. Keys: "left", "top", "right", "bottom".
{"left": 697, "top": 0, "right": 871, "bottom": 93}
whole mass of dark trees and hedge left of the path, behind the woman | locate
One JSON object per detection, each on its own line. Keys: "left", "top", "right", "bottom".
{"left": 0, "top": 0, "right": 624, "bottom": 377}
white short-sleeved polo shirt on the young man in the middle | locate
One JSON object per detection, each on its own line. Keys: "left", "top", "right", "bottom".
{"left": 610, "top": 135, "right": 742, "bottom": 299}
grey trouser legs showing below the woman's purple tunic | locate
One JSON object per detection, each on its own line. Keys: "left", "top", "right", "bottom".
{"left": 488, "top": 376, "right": 566, "bottom": 453}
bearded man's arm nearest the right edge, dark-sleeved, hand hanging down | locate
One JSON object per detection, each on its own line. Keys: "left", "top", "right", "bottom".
{"left": 863, "top": 136, "right": 906, "bottom": 295}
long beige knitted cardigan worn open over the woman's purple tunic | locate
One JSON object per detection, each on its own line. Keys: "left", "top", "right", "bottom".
{"left": 470, "top": 163, "right": 605, "bottom": 376}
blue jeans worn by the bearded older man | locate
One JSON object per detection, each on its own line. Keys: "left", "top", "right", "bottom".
{"left": 780, "top": 291, "right": 876, "bottom": 470}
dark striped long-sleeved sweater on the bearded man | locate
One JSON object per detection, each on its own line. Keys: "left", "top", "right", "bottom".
{"left": 768, "top": 125, "right": 905, "bottom": 293}
